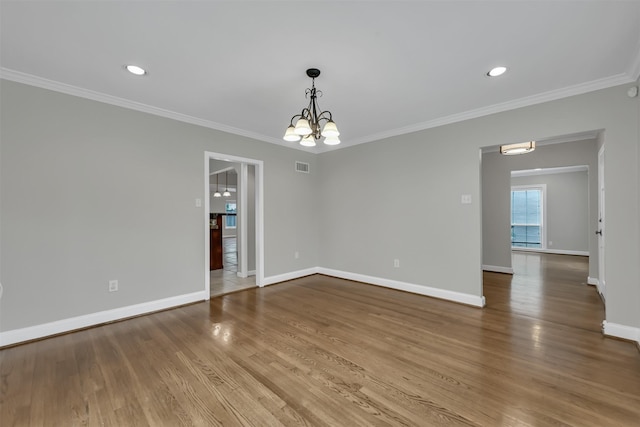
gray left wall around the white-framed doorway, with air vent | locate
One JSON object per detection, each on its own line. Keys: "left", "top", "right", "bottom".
{"left": 0, "top": 80, "right": 318, "bottom": 331}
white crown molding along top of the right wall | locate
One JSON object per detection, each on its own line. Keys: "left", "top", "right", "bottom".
{"left": 336, "top": 71, "right": 640, "bottom": 149}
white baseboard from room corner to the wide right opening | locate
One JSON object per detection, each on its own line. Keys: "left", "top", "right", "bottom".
{"left": 317, "top": 267, "right": 485, "bottom": 307}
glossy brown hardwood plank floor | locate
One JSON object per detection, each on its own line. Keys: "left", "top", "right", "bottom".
{"left": 0, "top": 253, "right": 640, "bottom": 427}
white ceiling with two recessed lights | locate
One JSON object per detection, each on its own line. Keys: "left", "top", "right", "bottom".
{"left": 0, "top": 0, "right": 640, "bottom": 151}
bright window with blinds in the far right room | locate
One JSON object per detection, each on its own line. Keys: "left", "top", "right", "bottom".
{"left": 511, "top": 185, "right": 544, "bottom": 249}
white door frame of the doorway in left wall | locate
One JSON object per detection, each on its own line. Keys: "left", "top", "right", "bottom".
{"left": 204, "top": 151, "right": 264, "bottom": 300}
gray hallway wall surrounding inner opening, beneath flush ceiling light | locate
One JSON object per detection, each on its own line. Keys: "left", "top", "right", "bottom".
{"left": 482, "top": 141, "right": 606, "bottom": 278}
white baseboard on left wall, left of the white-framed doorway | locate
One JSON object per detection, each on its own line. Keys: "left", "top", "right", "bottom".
{"left": 0, "top": 291, "right": 209, "bottom": 346}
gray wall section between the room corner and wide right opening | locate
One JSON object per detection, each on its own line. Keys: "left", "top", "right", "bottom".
{"left": 319, "top": 127, "right": 482, "bottom": 296}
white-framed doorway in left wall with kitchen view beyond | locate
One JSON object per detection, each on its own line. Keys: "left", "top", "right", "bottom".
{"left": 204, "top": 151, "right": 264, "bottom": 296}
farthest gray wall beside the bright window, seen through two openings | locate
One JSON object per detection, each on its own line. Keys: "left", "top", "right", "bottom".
{"left": 511, "top": 171, "right": 597, "bottom": 255}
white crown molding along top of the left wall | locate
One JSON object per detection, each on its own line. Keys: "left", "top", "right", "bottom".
{"left": 0, "top": 67, "right": 316, "bottom": 151}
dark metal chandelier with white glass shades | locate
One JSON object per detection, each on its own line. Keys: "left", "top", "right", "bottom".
{"left": 284, "top": 68, "right": 340, "bottom": 147}
